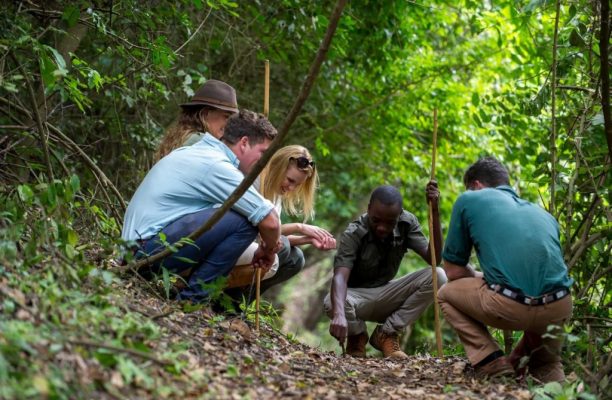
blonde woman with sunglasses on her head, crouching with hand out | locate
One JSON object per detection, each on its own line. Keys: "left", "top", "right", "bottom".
{"left": 228, "top": 145, "right": 336, "bottom": 293}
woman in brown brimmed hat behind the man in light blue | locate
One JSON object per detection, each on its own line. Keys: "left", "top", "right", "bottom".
{"left": 155, "top": 79, "right": 238, "bottom": 161}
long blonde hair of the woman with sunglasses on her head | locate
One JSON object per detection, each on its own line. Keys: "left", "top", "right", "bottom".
{"left": 260, "top": 145, "right": 319, "bottom": 221}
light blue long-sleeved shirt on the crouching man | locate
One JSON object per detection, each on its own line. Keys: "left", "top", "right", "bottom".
{"left": 121, "top": 133, "right": 274, "bottom": 241}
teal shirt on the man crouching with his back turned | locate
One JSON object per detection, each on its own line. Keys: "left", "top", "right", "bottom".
{"left": 442, "top": 185, "right": 573, "bottom": 296}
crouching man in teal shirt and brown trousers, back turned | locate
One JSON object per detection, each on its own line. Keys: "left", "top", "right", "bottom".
{"left": 438, "top": 157, "right": 573, "bottom": 382}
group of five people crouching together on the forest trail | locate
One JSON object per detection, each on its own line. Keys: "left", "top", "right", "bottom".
{"left": 122, "top": 80, "right": 572, "bottom": 382}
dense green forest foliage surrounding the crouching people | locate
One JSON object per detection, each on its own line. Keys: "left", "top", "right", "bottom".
{"left": 0, "top": 0, "right": 612, "bottom": 397}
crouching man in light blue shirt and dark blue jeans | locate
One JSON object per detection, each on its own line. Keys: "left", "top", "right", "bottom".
{"left": 121, "top": 110, "right": 280, "bottom": 302}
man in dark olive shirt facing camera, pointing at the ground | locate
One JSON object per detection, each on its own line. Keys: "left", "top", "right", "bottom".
{"left": 324, "top": 181, "right": 446, "bottom": 358}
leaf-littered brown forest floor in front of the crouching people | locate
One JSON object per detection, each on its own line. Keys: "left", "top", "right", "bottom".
{"left": 120, "top": 282, "right": 531, "bottom": 399}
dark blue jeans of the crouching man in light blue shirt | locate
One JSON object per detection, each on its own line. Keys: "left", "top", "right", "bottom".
{"left": 143, "top": 208, "right": 258, "bottom": 303}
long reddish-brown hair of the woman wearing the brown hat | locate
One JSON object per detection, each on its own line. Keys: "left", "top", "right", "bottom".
{"left": 153, "top": 106, "right": 213, "bottom": 163}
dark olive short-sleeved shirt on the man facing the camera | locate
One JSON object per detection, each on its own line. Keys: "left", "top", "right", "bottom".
{"left": 334, "top": 210, "right": 429, "bottom": 288}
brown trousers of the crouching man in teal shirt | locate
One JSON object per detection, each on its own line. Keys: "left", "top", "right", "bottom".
{"left": 438, "top": 278, "right": 572, "bottom": 379}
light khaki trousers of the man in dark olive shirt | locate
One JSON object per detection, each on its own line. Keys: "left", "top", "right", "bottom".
{"left": 323, "top": 268, "right": 446, "bottom": 336}
